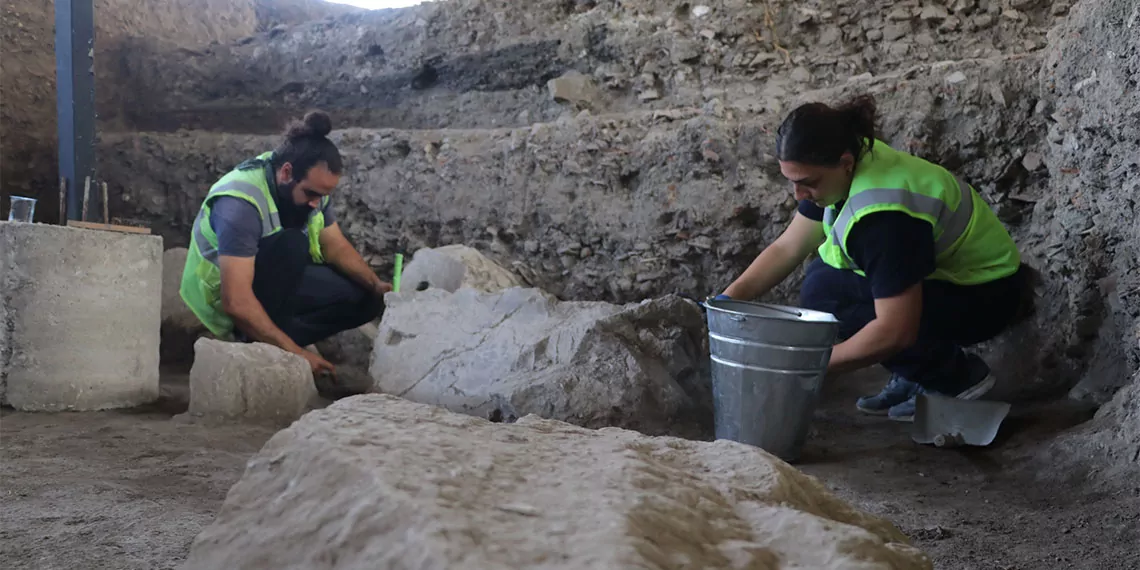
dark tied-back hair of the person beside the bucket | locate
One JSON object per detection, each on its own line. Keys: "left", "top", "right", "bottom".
{"left": 776, "top": 95, "right": 876, "bottom": 166}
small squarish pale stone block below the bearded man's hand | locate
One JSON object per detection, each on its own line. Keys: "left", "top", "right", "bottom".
{"left": 188, "top": 339, "right": 317, "bottom": 422}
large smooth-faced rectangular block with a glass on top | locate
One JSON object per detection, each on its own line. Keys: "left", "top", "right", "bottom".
{"left": 0, "top": 222, "right": 162, "bottom": 410}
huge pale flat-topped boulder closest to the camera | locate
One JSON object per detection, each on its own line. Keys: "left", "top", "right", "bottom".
{"left": 175, "top": 394, "right": 933, "bottom": 570}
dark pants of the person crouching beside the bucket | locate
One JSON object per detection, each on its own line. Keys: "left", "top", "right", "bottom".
{"left": 800, "top": 259, "right": 1026, "bottom": 393}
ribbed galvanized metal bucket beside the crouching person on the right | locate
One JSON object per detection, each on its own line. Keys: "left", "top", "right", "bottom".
{"left": 703, "top": 300, "right": 839, "bottom": 462}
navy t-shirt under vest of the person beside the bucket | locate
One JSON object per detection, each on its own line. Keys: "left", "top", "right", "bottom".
{"left": 797, "top": 200, "right": 936, "bottom": 299}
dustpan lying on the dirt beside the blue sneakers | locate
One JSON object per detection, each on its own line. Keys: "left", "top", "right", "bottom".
{"left": 911, "top": 393, "right": 1010, "bottom": 447}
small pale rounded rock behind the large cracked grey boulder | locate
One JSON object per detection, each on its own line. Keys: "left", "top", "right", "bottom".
{"left": 400, "top": 245, "right": 524, "bottom": 293}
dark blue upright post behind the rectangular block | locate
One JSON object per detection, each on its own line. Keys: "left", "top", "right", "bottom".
{"left": 49, "top": 0, "right": 96, "bottom": 221}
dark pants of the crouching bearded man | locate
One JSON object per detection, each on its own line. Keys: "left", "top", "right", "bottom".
{"left": 253, "top": 229, "right": 384, "bottom": 347}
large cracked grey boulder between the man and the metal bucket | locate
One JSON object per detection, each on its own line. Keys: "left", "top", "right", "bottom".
{"left": 369, "top": 287, "right": 713, "bottom": 437}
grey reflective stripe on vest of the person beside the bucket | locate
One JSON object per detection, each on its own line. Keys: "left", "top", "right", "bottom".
{"left": 824, "top": 177, "right": 974, "bottom": 266}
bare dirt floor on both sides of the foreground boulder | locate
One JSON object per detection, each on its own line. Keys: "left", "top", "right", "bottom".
{"left": 0, "top": 367, "right": 1140, "bottom": 570}
